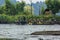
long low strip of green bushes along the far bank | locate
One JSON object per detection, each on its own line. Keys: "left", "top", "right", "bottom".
{"left": 0, "top": 14, "right": 60, "bottom": 24}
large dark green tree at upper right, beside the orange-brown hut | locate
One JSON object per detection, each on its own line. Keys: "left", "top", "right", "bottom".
{"left": 45, "top": 0, "right": 60, "bottom": 14}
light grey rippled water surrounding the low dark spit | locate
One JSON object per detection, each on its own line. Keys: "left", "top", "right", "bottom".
{"left": 0, "top": 24, "right": 60, "bottom": 40}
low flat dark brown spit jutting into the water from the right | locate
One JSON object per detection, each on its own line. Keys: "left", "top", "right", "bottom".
{"left": 31, "top": 31, "right": 60, "bottom": 35}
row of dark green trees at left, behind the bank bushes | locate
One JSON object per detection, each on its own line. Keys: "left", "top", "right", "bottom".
{"left": 0, "top": 0, "right": 31, "bottom": 15}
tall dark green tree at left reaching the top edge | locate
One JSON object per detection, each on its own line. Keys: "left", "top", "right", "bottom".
{"left": 5, "top": 0, "right": 16, "bottom": 15}
